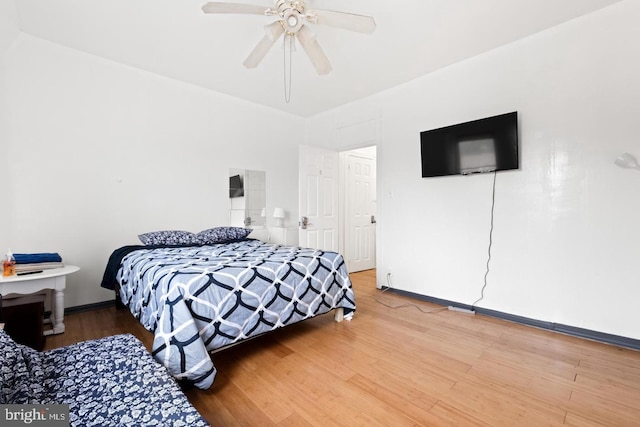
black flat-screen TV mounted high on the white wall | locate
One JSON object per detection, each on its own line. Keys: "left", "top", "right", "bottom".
{"left": 420, "top": 111, "right": 519, "bottom": 178}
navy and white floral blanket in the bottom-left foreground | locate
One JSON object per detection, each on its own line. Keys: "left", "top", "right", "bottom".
{"left": 0, "top": 330, "right": 209, "bottom": 427}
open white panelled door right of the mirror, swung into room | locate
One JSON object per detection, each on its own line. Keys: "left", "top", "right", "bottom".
{"left": 298, "top": 146, "right": 340, "bottom": 252}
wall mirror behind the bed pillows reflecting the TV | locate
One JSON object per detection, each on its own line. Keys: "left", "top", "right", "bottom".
{"left": 229, "top": 169, "right": 267, "bottom": 228}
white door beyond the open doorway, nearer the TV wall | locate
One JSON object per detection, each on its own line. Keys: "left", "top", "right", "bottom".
{"left": 345, "top": 154, "right": 376, "bottom": 273}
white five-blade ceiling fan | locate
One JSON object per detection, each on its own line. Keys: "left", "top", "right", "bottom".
{"left": 202, "top": 0, "right": 376, "bottom": 74}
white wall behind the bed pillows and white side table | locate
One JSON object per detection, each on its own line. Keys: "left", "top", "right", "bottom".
{"left": 0, "top": 34, "right": 304, "bottom": 307}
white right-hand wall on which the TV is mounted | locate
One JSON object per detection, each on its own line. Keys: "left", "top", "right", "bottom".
{"left": 307, "top": 0, "right": 640, "bottom": 339}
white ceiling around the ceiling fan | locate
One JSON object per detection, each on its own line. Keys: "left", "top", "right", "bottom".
{"left": 15, "top": 0, "right": 619, "bottom": 117}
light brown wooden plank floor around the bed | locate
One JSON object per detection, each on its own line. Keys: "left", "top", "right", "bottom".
{"left": 47, "top": 271, "right": 640, "bottom": 427}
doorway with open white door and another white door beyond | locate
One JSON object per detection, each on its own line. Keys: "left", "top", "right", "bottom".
{"left": 298, "top": 145, "right": 377, "bottom": 273}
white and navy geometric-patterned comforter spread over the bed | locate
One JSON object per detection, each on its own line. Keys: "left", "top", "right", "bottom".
{"left": 109, "top": 239, "right": 356, "bottom": 389}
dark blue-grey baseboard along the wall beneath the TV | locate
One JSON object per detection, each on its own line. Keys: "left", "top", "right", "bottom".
{"left": 387, "top": 288, "right": 640, "bottom": 350}
